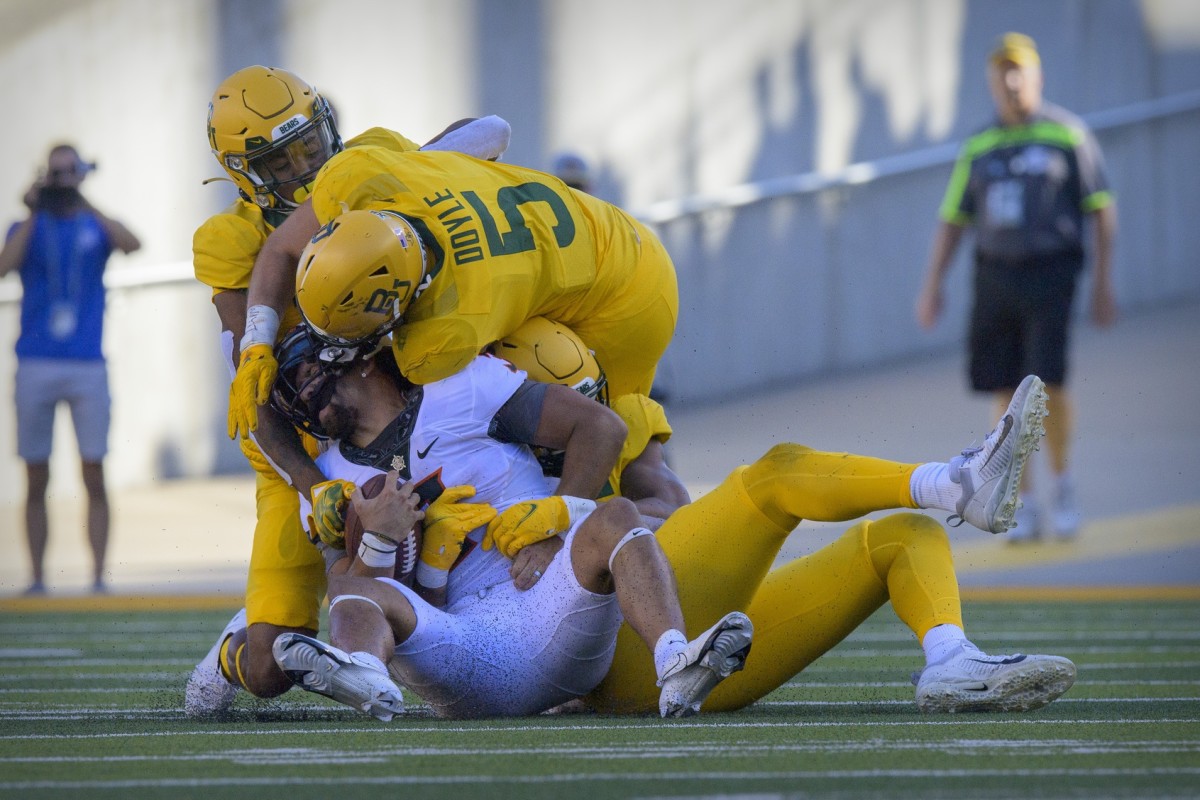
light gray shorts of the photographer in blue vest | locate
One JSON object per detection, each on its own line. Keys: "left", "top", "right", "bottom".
{"left": 16, "top": 359, "right": 112, "bottom": 464}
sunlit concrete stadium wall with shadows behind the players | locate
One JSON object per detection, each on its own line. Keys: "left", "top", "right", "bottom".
{"left": 0, "top": 0, "right": 1200, "bottom": 503}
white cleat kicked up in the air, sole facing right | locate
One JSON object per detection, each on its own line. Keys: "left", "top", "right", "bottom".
{"left": 947, "top": 375, "right": 1046, "bottom": 534}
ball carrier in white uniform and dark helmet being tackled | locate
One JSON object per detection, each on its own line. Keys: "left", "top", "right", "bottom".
{"left": 266, "top": 330, "right": 752, "bottom": 720}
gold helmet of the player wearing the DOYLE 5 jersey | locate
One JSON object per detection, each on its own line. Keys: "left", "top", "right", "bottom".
{"left": 296, "top": 211, "right": 427, "bottom": 347}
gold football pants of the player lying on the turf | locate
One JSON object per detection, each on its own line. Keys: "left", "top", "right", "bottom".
{"left": 584, "top": 444, "right": 962, "bottom": 712}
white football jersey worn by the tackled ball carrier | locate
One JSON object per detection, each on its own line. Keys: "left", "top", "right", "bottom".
{"left": 317, "top": 355, "right": 553, "bottom": 608}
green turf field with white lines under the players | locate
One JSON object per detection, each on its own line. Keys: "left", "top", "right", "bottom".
{"left": 0, "top": 601, "right": 1200, "bottom": 800}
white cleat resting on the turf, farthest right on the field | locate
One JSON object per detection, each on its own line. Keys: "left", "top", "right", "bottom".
{"left": 913, "top": 646, "right": 1075, "bottom": 714}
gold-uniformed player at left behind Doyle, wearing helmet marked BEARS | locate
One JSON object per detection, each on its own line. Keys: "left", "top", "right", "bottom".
{"left": 185, "top": 66, "right": 510, "bottom": 716}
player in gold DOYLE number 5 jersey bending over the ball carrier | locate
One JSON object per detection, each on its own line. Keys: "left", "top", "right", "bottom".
{"left": 223, "top": 148, "right": 679, "bottom": 443}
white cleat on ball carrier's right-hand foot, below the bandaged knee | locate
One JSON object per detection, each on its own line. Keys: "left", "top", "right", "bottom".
{"left": 659, "top": 612, "right": 754, "bottom": 717}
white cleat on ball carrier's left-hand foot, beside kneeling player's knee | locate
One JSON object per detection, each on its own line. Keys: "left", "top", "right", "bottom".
{"left": 271, "top": 632, "right": 404, "bottom": 722}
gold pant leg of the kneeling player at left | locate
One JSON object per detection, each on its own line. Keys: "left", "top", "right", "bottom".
{"left": 246, "top": 473, "right": 325, "bottom": 630}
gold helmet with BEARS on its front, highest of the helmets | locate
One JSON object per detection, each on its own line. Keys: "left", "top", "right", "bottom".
{"left": 209, "top": 66, "right": 342, "bottom": 213}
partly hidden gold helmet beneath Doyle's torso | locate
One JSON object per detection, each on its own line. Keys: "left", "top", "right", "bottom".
{"left": 490, "top": 317, "right": 608, "bottom": 405}
